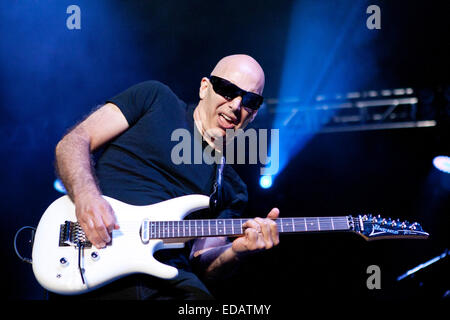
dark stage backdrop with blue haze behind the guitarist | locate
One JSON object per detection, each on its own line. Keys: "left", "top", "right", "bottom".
{"left": 0, "top": 0, "right": 450, "bottom": 301}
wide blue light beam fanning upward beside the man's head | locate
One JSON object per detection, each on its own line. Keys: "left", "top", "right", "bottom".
{"left": 272, "top": 0, "right": 370, "bottom": 176}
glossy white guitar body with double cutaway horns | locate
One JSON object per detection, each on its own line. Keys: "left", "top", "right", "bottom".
{"left": 32, "top": 195, "right": 209, "bottom": 295}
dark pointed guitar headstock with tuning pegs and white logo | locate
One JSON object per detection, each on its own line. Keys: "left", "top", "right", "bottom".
{"left": 352, "top": 215, "right": 429, "bottom": 241}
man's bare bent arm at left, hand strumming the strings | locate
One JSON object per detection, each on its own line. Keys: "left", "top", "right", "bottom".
{"left": 55, "top": 103, "right": 129, "bottom": 248}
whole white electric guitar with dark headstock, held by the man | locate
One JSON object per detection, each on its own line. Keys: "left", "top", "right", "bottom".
{"left": 32, "top": 195, "right": 428, "bottom": 295}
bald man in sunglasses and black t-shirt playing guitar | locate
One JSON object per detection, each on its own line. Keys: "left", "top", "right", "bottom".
{"left": 51, "top": 55, "right": 279, "bottom": 299}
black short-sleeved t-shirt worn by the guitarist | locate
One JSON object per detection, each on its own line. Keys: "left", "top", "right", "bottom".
{"left": 96, "top": 81, "right": 248, "bottom": 268}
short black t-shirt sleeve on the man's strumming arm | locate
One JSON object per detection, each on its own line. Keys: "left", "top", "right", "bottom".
{"left": 106, "top": 80, "right": 166, "bottom": 126}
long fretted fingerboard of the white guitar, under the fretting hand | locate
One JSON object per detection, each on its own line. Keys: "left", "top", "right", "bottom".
{"left": 148, "top": 216, "right": 351, "bottom": 239}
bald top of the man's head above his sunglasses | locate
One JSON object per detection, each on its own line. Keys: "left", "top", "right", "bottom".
{"left": 211, "top": 54, "right": 265, "bottom": 94}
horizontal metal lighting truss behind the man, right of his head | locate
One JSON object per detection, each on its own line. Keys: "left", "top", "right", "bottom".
{"left": 261, "top": 88, "right": 436, "bottom": 133}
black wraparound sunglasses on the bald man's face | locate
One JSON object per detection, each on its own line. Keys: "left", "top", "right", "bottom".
{"left": 209, "top": 76, "right": 264, "bottom": 110}
